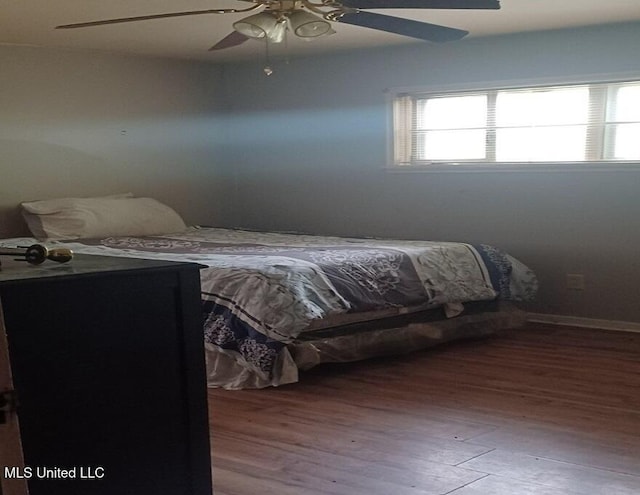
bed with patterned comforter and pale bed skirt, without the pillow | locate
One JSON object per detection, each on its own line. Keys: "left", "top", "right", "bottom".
{"left": 0, "top": 197, "right": 537, "bottom": 389}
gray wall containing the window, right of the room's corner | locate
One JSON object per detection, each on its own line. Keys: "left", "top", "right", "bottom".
{"left": 221, "top": 24, "right": 640, "bottom": 322}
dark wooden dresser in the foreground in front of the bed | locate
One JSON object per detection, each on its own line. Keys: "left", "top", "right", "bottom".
{"left": 0, "top": 255, "right": 212, "bottom": 495}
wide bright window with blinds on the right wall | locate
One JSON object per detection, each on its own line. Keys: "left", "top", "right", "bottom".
{"left": 392, "top": 81, "right": 640, "bottom": 166}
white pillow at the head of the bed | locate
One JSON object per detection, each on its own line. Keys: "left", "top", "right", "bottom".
{"left": 21, "top": 194, "right": 187, "bottom": 240}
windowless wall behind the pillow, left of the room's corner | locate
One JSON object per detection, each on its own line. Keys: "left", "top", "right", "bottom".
{"left": 0, "top": 46, "right": 227, "bottom": 237}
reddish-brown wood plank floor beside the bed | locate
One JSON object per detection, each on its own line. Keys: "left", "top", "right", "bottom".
{"left": 209, "top": 325, "right": 640, "bottom": 495}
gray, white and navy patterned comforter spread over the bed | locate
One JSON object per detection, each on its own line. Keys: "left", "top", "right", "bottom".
{"left": 3, "top": 227, "right": 537, "bottom": 388}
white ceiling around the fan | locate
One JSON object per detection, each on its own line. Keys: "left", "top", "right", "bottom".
{"left": 0, "top": 0, "right": 640, "bottom": 62}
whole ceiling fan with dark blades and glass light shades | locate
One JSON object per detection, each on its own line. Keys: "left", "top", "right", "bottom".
{"left": 56, "top": 0, "right": 500, "bottom": 50}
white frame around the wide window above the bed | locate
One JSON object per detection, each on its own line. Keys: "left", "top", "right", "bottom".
{"left": 385, "top": 72, "right": 640, "bottom": 172}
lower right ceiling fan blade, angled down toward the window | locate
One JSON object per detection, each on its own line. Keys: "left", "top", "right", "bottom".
{"left": 336, "top": 11, "right": 469, "bottom": 43}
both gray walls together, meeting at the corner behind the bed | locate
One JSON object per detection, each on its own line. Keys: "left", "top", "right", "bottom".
{"left": 0, "top": 24, "right": 640, "bottom": 322}
